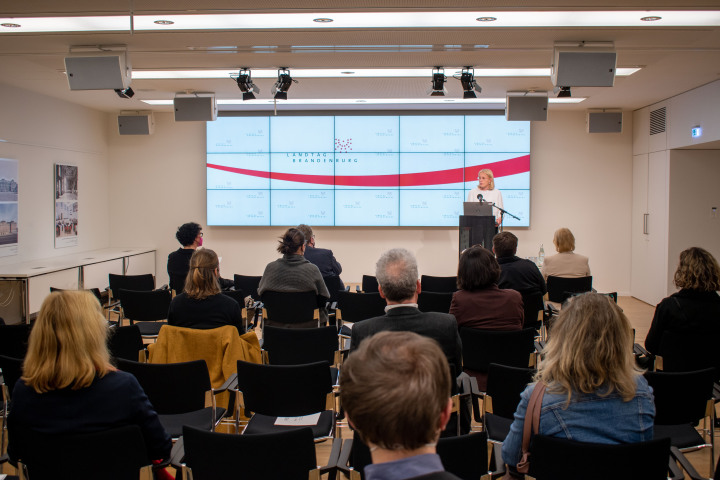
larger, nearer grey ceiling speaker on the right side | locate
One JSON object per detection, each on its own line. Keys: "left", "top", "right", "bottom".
{"left": 551, "top": 47, "right": 617, "bottom": 87}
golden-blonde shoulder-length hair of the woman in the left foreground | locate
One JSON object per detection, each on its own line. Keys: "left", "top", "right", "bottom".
{"left": 22, "top": 290, "right": 113, "bottom": 393}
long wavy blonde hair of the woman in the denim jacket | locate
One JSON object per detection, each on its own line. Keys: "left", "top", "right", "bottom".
{"left": 535, "top": 293, "right": 641, "bottom": 404}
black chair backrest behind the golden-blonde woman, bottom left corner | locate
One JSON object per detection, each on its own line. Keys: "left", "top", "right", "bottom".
{"left": 12, "top": 425, "right": 150, "bottom": 480}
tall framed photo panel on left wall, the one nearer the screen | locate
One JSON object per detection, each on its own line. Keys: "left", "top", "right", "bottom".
{"left": 55, "top": 163, "right": 78, "bottom": 248}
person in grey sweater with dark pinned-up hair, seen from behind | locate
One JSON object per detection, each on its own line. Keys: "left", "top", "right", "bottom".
{"left": 258, "top": 228, "right": 330, "bottom": 327}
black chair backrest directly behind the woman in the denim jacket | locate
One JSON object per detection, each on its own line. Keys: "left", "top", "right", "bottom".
{"left": 529, "top": 435, "right": 670, "bottom": 480}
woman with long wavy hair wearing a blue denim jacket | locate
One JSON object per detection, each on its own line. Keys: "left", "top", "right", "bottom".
{"left": 502, "top": 293, "right": 655, "bottom": 467}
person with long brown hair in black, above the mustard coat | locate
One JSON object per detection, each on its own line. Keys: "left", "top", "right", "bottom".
{"left": 168, "top": 248, "right": 245, "bottom": 335}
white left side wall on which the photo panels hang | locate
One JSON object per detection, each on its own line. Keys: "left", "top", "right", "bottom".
{"left": 0, "top": 85, "right": 112, "bottom": 265}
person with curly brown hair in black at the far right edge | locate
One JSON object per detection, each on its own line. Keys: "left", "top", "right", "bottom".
{"left": 645, "top": 247, "right": 720, "bottom": 356}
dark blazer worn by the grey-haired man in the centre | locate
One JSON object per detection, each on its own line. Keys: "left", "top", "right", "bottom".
{"left": 350, "top": 307, "right": 462, "bottom": 371}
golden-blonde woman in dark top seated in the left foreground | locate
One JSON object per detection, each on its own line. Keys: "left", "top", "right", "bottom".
{"left": 8, "top": 291, "right": 172, "bottom": 464}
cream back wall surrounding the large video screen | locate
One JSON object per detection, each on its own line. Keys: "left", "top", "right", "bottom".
{"left": 107, "top": 111, "right": 632, "bottom": 294}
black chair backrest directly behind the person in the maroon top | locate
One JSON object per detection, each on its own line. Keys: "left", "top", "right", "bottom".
{"left": 460, "top": 327, "right": 537, "bottom": 372}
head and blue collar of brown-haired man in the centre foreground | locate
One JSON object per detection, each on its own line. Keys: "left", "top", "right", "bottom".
{"left": 340, "top": 331, "right": 457, "bottom": 480}
